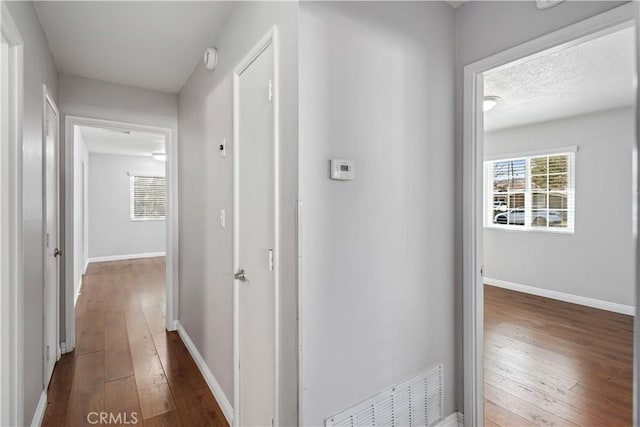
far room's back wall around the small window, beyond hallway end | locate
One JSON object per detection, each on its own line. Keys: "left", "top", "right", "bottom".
{"left": 89, "top": 153, "right": 166, "bottom": 259}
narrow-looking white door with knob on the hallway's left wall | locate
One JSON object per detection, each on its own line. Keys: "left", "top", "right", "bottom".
{"left": 43, "top": 89, "right": 61, "bottom": 388}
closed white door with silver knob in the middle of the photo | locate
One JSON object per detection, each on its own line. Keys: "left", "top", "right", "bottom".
{"left": 234, "top": 41, "right": 275, "bottom": 426}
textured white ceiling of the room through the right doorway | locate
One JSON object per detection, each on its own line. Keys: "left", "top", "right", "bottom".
{"left": 484, "top": 28, "right": 637, "bottom": 131}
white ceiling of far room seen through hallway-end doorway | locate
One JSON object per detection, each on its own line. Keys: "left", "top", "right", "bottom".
{"left": 78, "top": 126, "right": 165, "bottom": 156}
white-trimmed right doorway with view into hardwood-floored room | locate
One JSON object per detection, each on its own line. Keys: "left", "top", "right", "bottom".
{"left": 464, "top": 5, "right": 638, "bottom": 425}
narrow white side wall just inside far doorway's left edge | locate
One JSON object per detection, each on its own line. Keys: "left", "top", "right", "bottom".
{"left": 73, "top": 126, "right": 89, "bottom": 298}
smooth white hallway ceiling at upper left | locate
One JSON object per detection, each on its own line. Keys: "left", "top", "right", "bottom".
{"left": 35, "top": 1, "right": 235, "bottom": 93}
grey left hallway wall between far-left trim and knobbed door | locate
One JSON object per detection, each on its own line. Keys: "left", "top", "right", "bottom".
{"left": 7, "top": 2, "right": 58, "bottom": 424}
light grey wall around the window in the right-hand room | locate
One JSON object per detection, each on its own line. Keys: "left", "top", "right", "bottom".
{"left": 484, "top": 108, "right": 635, "bottom": 306}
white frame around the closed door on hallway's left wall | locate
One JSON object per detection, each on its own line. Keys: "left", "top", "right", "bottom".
{"left": 42, "top": 84, "right": 61, "bottom": 391}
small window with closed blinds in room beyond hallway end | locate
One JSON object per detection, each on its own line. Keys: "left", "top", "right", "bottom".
{"left": 129, "top": 175, "right": 167, "bottom": 221}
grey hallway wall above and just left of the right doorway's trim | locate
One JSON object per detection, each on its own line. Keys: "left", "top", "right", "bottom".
{"left": 454, "top": 0, "right": 626, "bottom": 410}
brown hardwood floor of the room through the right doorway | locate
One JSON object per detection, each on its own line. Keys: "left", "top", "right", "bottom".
{"left": 484, "top": 285, "right": 633, "bottom": 427}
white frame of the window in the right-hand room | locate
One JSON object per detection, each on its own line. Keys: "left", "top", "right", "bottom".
{"left": 483, "top": 146, "right": 578, "bottom": 234}
